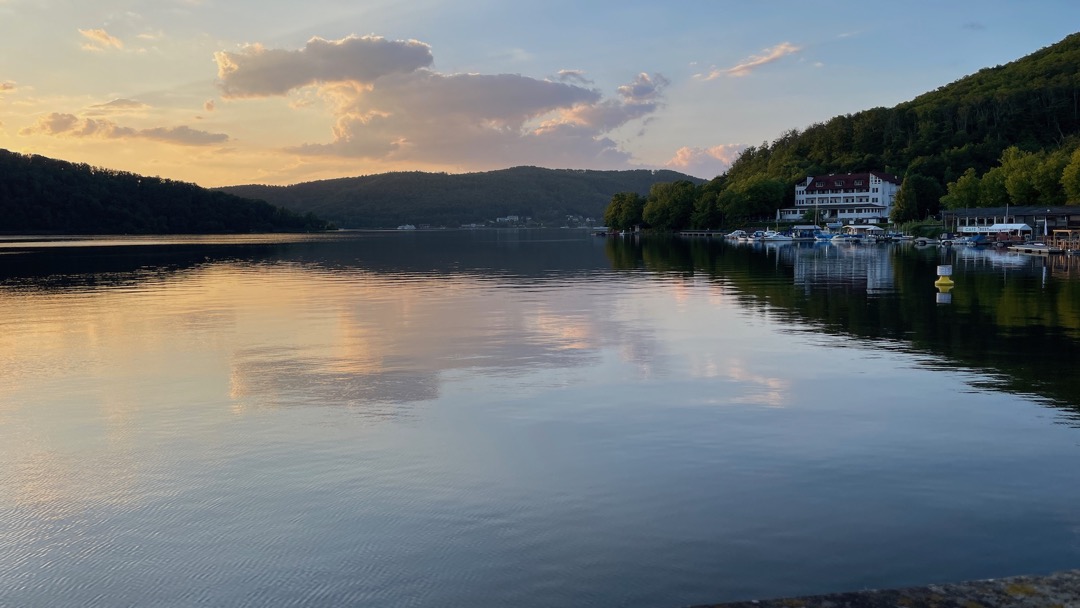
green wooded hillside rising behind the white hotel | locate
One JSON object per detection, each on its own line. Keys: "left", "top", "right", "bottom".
{"left": 610, "top": 35, "right": 1080, "bottom": 229}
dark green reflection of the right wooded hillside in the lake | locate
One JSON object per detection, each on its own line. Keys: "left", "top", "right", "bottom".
{"left": 609, "top": 239, "right": 1080, "bottom": 420}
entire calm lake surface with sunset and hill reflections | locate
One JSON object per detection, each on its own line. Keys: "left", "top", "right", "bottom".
{"left": 0, "top": 230, "right": 1080, "bottom": 608}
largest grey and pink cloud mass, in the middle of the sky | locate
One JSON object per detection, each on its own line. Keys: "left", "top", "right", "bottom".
{"left": 217, "top": 37, "right": 669, "bottom": 168}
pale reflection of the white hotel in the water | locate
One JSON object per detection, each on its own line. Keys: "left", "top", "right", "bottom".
{"left": 787, "top": 243, "right": 896, "bottom": 294}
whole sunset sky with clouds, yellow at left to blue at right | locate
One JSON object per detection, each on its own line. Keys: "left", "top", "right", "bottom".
{"left": 0, "top": 0, "right": 1080, "bottom": 187}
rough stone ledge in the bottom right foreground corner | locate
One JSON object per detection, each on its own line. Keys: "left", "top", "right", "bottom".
{"left": 699, "top": 570, "right": 1080, "bottom": 608}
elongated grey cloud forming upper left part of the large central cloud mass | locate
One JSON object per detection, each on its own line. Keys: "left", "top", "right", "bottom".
{"left": 214, "top": 36, "right": 433, "bottom": 98}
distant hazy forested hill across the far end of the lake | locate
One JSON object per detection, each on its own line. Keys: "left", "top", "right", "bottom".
{"left": 221, "top": 166, "right": 704, "bottom": 228}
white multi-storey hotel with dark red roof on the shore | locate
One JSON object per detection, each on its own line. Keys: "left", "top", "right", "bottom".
{"left": 777, "top": 171, "right": 900, "bottom": 224}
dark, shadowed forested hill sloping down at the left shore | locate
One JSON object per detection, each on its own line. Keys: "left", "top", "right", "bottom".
{"left": 0, "top": 149, "right": 327, "bottom": 234}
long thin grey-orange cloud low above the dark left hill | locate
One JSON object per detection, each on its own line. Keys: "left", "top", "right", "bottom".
{"left": 18, "top": 112, "right": 229, "bottom": 146}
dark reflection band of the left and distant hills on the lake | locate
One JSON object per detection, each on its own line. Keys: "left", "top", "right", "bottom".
{"left": 0, "top": 230, "right": 610, "bottom": 288}
